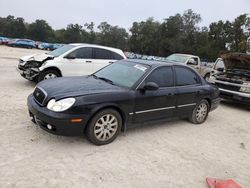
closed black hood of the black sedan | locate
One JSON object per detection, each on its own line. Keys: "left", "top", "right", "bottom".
{"left": 37, "top": 76, "right": 125, "bottom": 100}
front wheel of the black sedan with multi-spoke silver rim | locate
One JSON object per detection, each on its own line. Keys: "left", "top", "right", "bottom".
{"left": 85, "top": 109, "right": 122, "bottom": 145}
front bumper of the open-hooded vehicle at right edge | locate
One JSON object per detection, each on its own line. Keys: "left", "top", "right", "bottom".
{"left": 219, "top": 88, "right": 250, "bottom": 104}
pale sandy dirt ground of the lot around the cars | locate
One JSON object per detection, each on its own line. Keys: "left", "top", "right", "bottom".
{"left": 0, "top": 46, "right": 250, "bottom": 188}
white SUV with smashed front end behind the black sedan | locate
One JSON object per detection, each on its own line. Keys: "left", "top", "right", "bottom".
{"left": 17, "top": 44, "right": 126, "bottom": 82}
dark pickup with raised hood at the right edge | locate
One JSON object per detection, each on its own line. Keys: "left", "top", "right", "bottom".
{"left": 209, "top": 53, "right": 250, "bottom": 104}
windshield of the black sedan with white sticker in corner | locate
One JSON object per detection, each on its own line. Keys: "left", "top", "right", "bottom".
{"left": 93, "top": 61, "right": 149, "bottom": 87}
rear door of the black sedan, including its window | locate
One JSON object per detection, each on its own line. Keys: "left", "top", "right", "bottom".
{"left": 174, "top": 66, "right": 202, "bottom": 116}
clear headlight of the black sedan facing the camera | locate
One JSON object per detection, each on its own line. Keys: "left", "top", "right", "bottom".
{"left": 47, "top": 98, "right": 76, "bottom": 112}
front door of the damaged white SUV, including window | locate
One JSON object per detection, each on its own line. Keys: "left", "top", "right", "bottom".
{"left": 58, "top": 47, "right": 94, "bottom": 76}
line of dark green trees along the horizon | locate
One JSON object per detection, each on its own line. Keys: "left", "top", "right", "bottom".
{"left": 0, "top": 9, "right": 250, "bottom": 60}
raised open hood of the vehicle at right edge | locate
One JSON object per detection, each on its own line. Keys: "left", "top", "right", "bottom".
{"left": 221, "top": 53, "right": 250, "bottom": 71}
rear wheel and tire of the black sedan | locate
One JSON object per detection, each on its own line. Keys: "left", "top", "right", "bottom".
{"left": 189, "top": 99, "right": 210, "bottom": 124}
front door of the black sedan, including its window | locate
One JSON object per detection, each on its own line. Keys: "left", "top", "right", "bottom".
{"left": 133, "top": 66, "right": 176, "bottom": 123}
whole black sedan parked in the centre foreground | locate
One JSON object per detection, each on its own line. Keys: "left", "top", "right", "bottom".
{"left": 28, "top": 60, "right": 220, "bottom": 145}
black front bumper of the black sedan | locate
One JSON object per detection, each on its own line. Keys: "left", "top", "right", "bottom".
{"left": 27, "top": 94, "right": 87, "bottom": 136}
